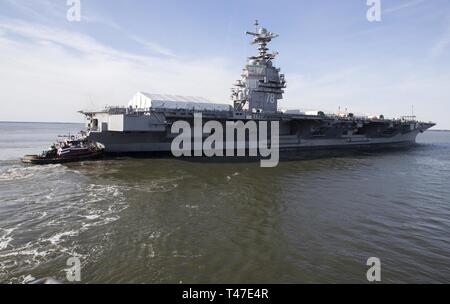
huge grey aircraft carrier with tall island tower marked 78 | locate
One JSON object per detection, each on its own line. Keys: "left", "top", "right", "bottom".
{"left": 80, "top": 23, "right": 435, "bottom": 154}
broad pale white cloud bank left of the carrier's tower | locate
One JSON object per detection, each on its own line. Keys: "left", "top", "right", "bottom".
{"left": 0, "top": 19, "right": 235, "bottom": 121}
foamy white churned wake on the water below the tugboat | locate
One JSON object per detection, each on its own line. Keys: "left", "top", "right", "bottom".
{"left": 0, "top": 165, "right": 129, "bottom": 283}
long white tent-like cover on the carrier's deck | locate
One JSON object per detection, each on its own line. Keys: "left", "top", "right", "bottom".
{"left": 128, "top": 92, "right": 231, "bottom": 111}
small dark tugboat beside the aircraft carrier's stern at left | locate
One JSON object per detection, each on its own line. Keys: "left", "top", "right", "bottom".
{"left": 22, "top": 136, "right": 105, "bottom": 165}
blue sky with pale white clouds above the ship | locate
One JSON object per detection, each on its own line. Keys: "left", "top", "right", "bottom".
{"left": 0, "top": 0, "right": 450, "bottom": 129}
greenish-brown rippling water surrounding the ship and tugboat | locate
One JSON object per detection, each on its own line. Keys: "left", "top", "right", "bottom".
{"left": 0, "top": 123, "right": 450, "bottom": 283}
